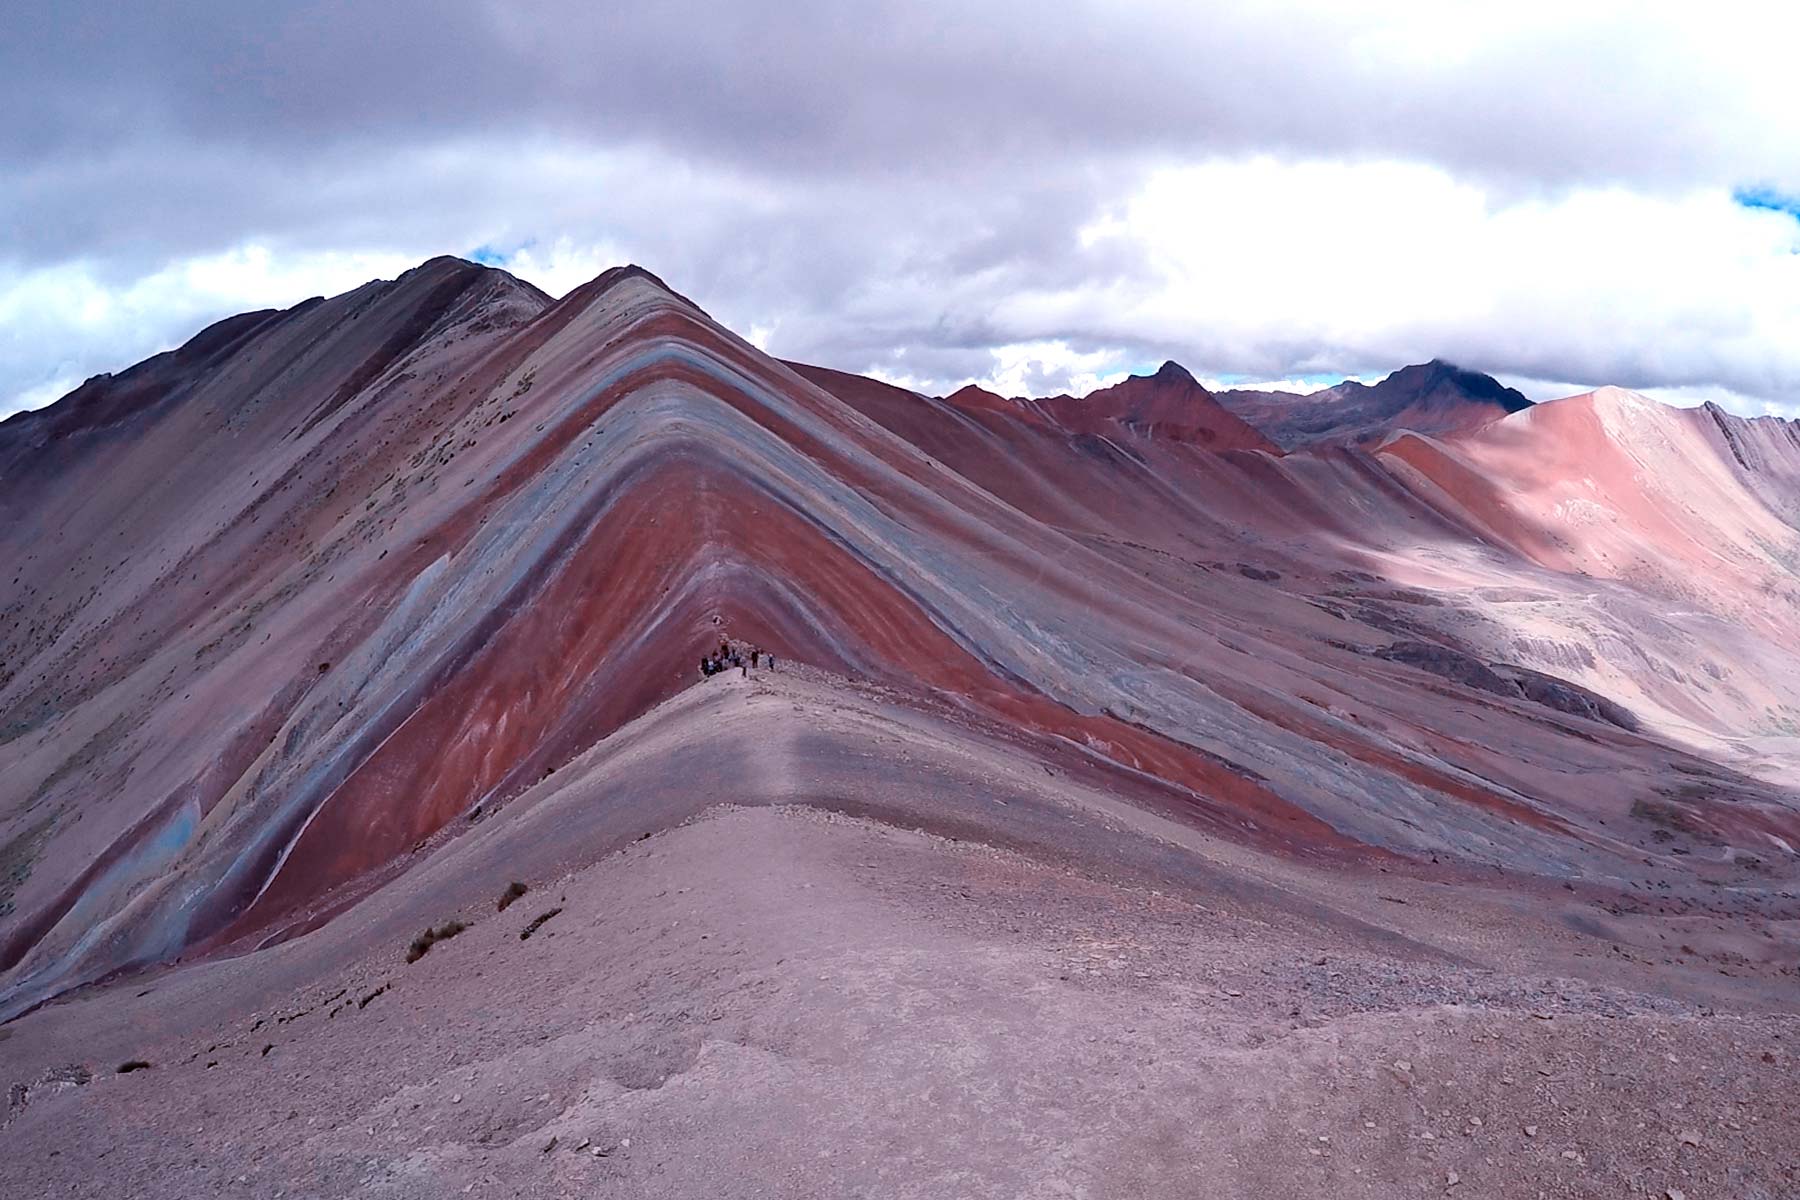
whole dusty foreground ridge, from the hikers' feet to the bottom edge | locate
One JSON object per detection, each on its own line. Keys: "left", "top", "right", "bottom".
{"left": 0, "top": 676, "right": 1800, "bottom": 1198}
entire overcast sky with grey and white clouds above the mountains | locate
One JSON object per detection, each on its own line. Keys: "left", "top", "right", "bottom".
{"left": 0, "top": 0, "right": 1800, "bottom": 416}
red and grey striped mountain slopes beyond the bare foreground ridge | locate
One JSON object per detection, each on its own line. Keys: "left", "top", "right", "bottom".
{"left": 0, "top": 259, "right": 1800, "bottom": 1013}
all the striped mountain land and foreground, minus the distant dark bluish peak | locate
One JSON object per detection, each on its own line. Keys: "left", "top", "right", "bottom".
{"left": 0, "top": 259, "right": 1800, "bottom": 1196}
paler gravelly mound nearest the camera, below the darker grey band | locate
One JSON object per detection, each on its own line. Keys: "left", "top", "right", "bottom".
{"left": 0, "top": 808, "right": 1800, "bottom": 1200}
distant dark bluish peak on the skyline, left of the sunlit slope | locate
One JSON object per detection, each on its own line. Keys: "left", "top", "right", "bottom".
{"left": 1219, "top": 358, "right": 1532, "bottom": 450}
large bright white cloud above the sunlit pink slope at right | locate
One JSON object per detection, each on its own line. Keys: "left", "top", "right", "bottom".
{"left": 1051, "top": 160, "right": 1800, "bottom": 399}
